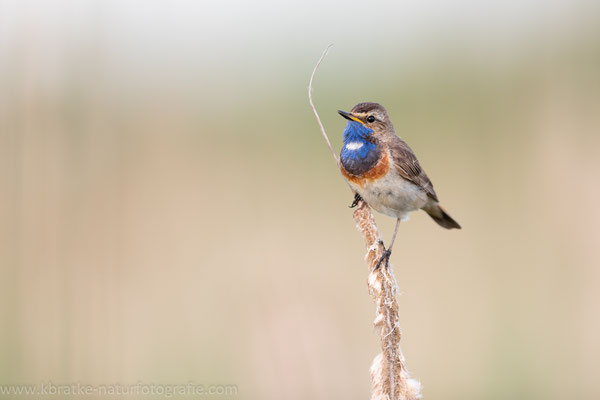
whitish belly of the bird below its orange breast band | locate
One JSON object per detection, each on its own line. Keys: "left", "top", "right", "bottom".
{"left": 348, "top": 171, "right": 429, "bottom": 219}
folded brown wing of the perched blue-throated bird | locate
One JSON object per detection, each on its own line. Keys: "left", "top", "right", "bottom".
{"left": 390, "top": 135, "right": 438, "bottom": 201}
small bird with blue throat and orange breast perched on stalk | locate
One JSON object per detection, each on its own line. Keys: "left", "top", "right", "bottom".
{"left": 338, "top": 102, "right": 461, "bottom": 269}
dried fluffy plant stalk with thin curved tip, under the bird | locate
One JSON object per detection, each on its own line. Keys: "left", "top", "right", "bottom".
{"left": 308, "top": 45, "right": 421, "bottom": 400}
